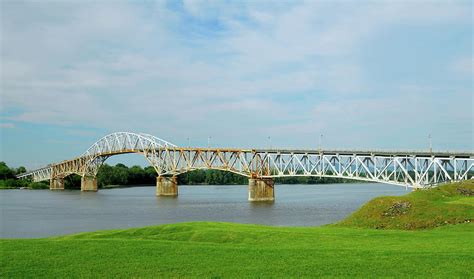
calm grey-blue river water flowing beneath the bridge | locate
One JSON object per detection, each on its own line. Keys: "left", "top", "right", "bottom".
{"left": 0, "top": 183, "right": 407, "bottom": 238}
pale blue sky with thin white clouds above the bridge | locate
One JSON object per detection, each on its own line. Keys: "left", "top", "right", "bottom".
{"left": 0, "top": 0, "right": 474, "bottom": 169}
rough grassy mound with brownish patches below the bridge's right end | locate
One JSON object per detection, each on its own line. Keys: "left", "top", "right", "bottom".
{"left": 338, "top": 180, "right": 474, "bottom": 230}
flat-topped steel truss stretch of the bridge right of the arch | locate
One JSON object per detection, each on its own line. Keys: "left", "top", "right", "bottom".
{"left": 148, "top": 148, "right": 474, "bottom": 188}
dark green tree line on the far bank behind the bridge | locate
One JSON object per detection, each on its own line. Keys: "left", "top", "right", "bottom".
{"left": 0, "top": 162, "right": 350, "bottom": 189}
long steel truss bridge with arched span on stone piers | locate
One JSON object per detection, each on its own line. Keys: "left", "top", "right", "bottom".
{"left": 18, "top": 132, "right": 474, "bottom": 201}
